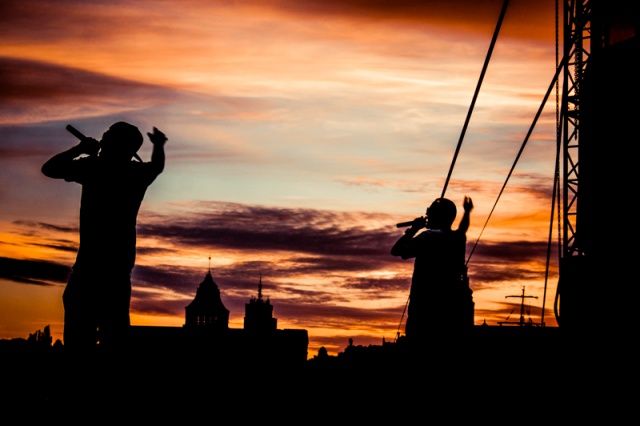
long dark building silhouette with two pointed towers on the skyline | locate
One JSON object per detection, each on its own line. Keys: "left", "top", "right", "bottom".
{"left": 131, "top": 270, "right": 309, "bottom": 367}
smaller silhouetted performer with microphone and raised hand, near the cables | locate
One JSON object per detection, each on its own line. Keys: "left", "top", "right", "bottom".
{"left": 391, "top": 197, "right": 473, "bottom": 345}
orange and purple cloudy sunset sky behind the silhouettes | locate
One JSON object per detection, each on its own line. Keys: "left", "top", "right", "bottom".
{"left": 0, "top": 0, "right": 558, "bottom": 357}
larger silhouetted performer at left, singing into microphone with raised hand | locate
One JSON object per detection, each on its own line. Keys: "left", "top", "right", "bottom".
{"left": 42, "top": 122, "right": 167, "bottom": 352}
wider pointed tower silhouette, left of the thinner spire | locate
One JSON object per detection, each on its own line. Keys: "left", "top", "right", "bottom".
{"left": 184, "top": 264, "right": 229, "bottom": 330}
